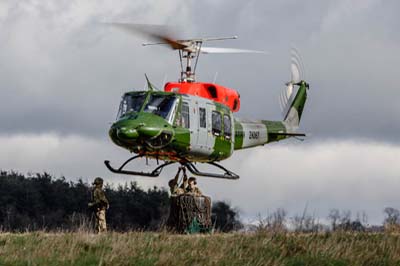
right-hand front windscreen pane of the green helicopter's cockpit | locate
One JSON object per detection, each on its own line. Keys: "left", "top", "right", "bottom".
{"left": 143, "top": 94, "right": 177, "bottom": 124}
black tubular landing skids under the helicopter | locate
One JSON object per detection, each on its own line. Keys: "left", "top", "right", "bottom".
{"left": 104, "top": 155, "right": 239, "bottom": 179}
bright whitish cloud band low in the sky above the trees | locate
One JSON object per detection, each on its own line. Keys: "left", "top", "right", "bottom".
{"left": 0, "top": 134, "right": 400, "bottom": 222}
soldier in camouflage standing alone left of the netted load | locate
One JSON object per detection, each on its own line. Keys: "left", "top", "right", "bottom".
{"left": 88, "top": 177, "right": 110, "bottom": 233}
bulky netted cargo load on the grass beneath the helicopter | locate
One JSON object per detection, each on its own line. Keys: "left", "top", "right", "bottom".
{"left": 167, "top": 194, "right": 212, "bottom": 233}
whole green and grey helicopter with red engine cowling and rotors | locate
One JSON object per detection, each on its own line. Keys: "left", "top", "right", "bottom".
{"left": 104, "top": 23, "right": 309, "bottom": 179}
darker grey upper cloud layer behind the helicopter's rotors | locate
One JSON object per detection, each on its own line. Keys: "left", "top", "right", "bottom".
{"left": 0, "top": 1, "right": 400, "bottom": 141}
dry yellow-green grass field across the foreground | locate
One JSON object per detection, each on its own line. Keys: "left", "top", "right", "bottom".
{"left": 0, "top": 232, "right": 400, "bottom": 266}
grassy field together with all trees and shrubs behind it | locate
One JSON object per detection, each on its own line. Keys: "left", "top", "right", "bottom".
{"left": 0, "top": 172, "right": 400, "bottom": 266}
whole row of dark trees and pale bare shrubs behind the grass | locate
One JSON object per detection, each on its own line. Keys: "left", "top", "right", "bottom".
{"left": 0, "top": 171, "right": 400, "bottom": 232}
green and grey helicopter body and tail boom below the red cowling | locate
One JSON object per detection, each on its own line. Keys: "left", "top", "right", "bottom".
{"left": 109, "top": 84, "right": 305, "bottom": 162}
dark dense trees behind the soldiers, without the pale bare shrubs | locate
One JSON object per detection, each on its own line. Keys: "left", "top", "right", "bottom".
{"left": 0, "top": 171, "right": 242, "bottom": 232}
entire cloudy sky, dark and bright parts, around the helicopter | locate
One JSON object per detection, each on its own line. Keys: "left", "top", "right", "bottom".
{"left": 0, "top": 0, "right": 400, "bottom": 223}
